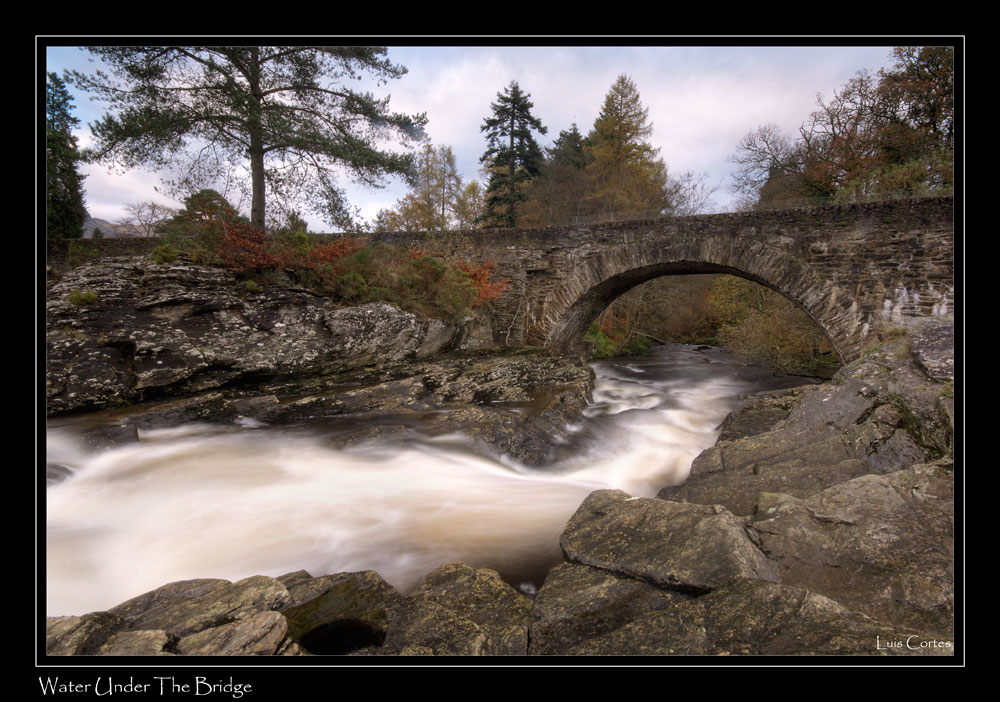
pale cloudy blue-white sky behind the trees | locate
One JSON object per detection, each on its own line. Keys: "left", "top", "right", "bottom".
{"left": 40, "top": 37, "right": 902, "bottom": 231}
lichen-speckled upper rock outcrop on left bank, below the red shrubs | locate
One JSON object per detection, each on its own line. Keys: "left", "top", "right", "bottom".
{"left": 46, "top": 257, "right": 461, "bottom": 414}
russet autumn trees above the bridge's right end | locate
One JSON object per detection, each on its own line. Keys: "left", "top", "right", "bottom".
{"left": 730, "top": 46, "right": 955, "bottom": 208}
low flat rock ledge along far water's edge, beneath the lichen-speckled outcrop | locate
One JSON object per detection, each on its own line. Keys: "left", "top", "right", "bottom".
{"left": 53, "top": 350, "right": 594, "bottom": 470}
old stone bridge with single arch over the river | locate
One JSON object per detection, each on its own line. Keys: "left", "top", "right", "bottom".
{"left": 377, "top": 198, "right": 955, "bottom": 362}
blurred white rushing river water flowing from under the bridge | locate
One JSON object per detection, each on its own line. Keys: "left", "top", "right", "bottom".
{"left": 46, "top": 345, "right": 809, "bottom": 616}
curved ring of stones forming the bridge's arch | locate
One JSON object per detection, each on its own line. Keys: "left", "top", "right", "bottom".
{"left": 542, "top": 236, "right": 868, "bottom": 363}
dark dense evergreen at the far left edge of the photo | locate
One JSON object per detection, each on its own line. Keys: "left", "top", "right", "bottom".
{"left": 45, "top": 73, "right": 87, "bottom": 239}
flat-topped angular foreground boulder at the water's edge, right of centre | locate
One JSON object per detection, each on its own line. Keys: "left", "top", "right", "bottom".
{"left": 559, "top": 490, "right": 777, "bottom": 594}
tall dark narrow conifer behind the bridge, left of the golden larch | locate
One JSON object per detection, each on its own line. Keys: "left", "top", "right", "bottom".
{"left": 479, "top": 80, "right": 548, "bottom": 227}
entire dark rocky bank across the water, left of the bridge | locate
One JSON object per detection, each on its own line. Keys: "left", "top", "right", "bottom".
{"left": 46, "top": 257, "right": 593, "bottom": 464}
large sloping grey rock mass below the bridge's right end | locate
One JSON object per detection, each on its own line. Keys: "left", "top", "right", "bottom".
{"left": 657, "top": 342, "right": 953, "bottom": 516}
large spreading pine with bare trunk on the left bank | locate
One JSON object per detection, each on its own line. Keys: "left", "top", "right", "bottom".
{"left": 67, "top": 46, "right": 426, "bottom": 228}
